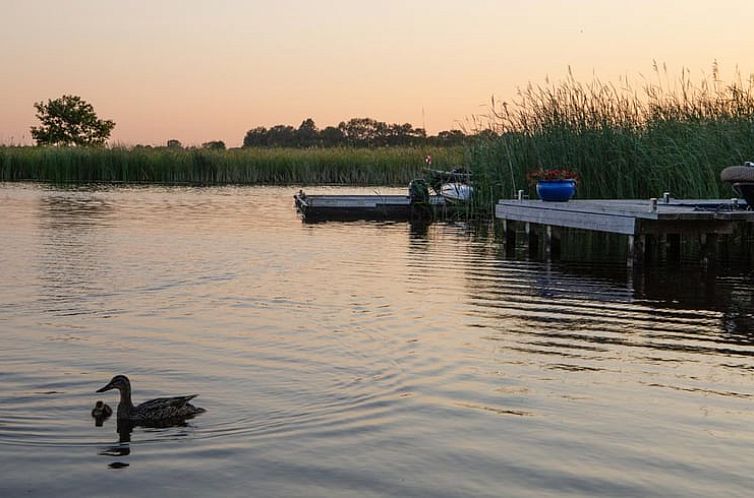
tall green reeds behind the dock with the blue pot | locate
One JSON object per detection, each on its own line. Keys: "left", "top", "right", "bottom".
{"left": 468, "top": 67, "right": 754, "bottom": 205}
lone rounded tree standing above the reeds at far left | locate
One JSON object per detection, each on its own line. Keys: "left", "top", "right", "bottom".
{"left": 31, "top": 95, "right": 115, "bottom": 145}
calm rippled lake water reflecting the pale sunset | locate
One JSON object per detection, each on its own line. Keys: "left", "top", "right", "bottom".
{"left": 0, "top": 184, "right": 754, "bottom": 497}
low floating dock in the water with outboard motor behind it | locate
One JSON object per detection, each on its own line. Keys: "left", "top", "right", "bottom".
{"left": 293, "top": 191, "right": 465, "bottom": 222}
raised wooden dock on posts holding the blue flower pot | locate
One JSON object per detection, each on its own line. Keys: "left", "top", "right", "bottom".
{"left": 495, "top": 195, "right": 754, "bottom": 265}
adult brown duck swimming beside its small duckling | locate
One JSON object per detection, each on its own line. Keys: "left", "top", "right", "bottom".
{"left": 97, "top": 375, "right": 206, "bottom": 424}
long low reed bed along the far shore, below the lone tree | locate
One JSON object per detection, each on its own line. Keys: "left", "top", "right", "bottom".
{"left": 0, "top": 146, "right": 464, "bottom": 186}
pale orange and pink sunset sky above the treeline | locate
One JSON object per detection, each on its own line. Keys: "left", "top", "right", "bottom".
{"left": 0, "top": 0, "right": 754, "bottom": 146}
